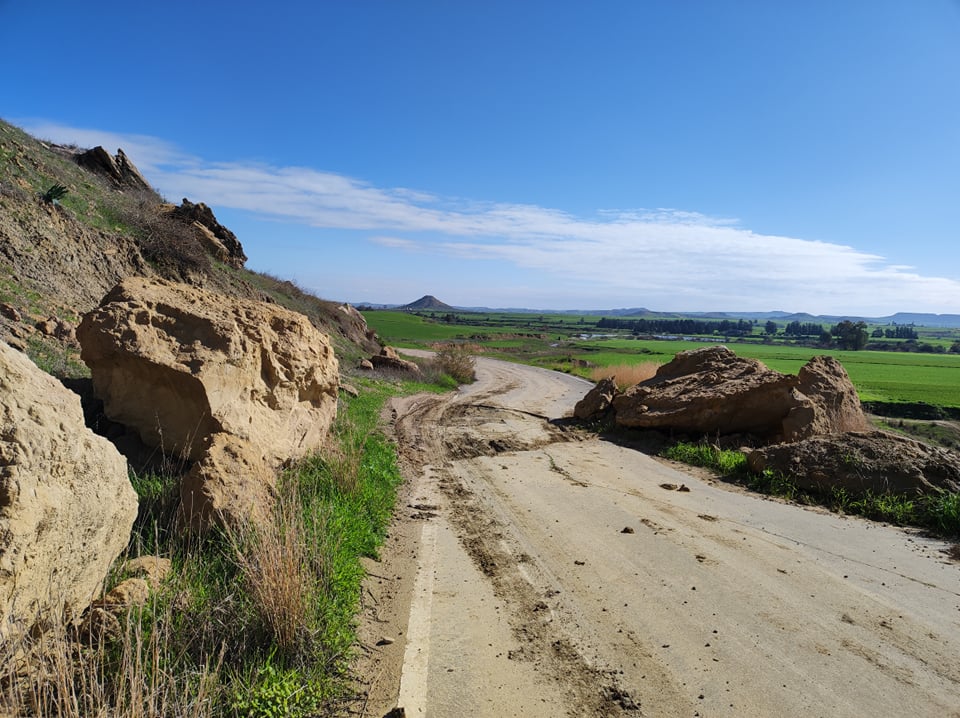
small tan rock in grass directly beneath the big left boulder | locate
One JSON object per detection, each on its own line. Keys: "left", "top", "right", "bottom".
{"left": 180, "top": 434, "right": 277, "bottom": 531}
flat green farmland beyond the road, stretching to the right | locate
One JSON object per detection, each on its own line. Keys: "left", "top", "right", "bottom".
{"left": 364, "top": 311, "right": 960, "bottom": 408}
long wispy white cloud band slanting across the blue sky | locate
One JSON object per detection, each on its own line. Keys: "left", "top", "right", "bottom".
{"left": 22, "top": 122, "right": 960, "bottom": 314}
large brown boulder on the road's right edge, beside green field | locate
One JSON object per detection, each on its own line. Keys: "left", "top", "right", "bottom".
{"left": 613, "top": 346, "right": 867, "bottom": 441}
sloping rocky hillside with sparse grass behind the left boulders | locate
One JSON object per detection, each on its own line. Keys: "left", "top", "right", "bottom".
{"left": 0, "top": 120, "right": 379, "bottom": 378}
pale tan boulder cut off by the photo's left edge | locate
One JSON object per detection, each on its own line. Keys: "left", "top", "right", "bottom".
{"left": 0, "top": 343, "right": 137, "bottom": 654}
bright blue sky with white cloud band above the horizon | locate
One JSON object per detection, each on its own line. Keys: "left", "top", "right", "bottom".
{"left": 0, "top": 0, "right": 960, "bottom": 316}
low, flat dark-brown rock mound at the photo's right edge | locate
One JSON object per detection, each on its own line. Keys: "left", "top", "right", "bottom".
{"left": 747, "top": 431, "right": 960, "bottom": 495}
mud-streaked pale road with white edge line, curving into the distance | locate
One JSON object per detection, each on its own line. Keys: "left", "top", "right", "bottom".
{"left": 358, "top": 359, "right": 960, "bottom": 718}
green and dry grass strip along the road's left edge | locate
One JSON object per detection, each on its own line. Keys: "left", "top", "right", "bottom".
{"left": 0, "top": 371, "right": 464, "bottom": 718}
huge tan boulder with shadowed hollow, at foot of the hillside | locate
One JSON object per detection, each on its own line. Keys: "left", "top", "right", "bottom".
{"left": 77, "top": 278, "right": 339, "bottom": 464}
